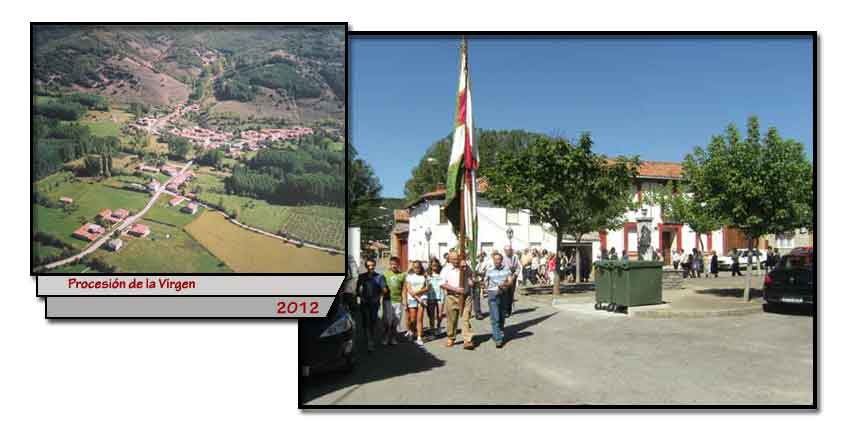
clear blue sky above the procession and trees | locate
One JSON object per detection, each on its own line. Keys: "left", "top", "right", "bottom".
{"left": 349, "top": 37, "right": 813, "bottom": 197}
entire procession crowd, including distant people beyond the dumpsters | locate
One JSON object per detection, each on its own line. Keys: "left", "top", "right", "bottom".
{"left": 355, "top": 246, "right": 779, "bottom": 352}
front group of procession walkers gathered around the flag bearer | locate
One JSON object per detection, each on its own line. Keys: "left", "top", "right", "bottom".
{"left": 355, "top": 247, "right": 522, "bottom": 352}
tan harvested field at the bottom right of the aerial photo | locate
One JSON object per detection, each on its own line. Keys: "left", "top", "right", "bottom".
{"left": 185, "top": 211, "right": 344, "bottom": 273}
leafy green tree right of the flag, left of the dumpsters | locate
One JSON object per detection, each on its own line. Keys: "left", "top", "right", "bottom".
{"left": 481, "top": 133, "right": 639, "bottom": 296}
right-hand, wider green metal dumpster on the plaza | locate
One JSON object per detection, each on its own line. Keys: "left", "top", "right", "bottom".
{"left": 611, "top": 261, "right": 663, "bottom": 309}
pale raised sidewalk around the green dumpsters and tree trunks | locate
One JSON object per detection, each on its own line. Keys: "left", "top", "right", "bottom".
{"left": 517, "top": 273, "right": 763, "bottom": 318}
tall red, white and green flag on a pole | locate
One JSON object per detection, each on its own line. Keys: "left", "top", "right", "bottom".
{"left": 445, "top": 39, "right": 479, "bottom": 260}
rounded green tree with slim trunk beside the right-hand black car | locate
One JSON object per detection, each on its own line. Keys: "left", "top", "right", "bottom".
{"left": 684, "top": 116, "right": 813, "bottom": 300}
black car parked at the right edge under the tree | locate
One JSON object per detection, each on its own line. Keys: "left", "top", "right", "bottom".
{"left": 764, "top": 247, "right": 815, "bottom": 307}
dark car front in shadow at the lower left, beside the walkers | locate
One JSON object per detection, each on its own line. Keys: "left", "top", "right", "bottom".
{"left": 299, "top": 294, "right": 355, "bottom": 376}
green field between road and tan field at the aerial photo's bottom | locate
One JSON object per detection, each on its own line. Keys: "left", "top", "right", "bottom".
{"left": 93, "top": 218, "right": 230, "bottom": 273}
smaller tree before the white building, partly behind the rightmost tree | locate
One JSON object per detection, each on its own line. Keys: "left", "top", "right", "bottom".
{"left": 643, "top": 181, "right": 725, "bottom": 249}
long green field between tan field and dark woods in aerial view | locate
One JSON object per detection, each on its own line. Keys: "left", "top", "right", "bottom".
{"left": 199, "top": 192, "right": 345, "bottom": 249}
